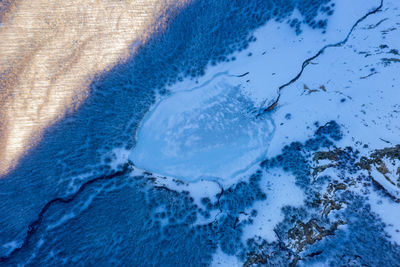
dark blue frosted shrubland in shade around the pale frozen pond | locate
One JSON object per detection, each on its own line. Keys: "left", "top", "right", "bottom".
{"left": 0, "top": 0, "right": 400, "bottom": 266}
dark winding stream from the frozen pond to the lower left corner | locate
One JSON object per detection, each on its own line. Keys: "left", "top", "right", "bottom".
{"left": 0, "top": 163, "right": 132, "bottom": 263}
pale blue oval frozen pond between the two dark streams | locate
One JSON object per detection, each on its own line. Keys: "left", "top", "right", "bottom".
{"left": 130, "top": 75, "right": 274, "bottom": 181}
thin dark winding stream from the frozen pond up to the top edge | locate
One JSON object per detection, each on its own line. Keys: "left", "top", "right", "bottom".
{"left": 258, "top": 0, "right": 383, "bottom": 116}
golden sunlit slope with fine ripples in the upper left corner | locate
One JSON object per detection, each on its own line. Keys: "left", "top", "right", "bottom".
{"left": 0, "top": 0, "right": 187, "bottom": 178}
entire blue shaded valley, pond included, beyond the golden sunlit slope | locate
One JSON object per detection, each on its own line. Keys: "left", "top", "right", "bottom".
{"left": 0, "top": 0, "right": 400, "bottom": 266}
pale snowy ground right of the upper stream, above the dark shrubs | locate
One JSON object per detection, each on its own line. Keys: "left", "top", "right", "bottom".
{"left": 269, "top": 1, "right": 400, "bottom": 157}
